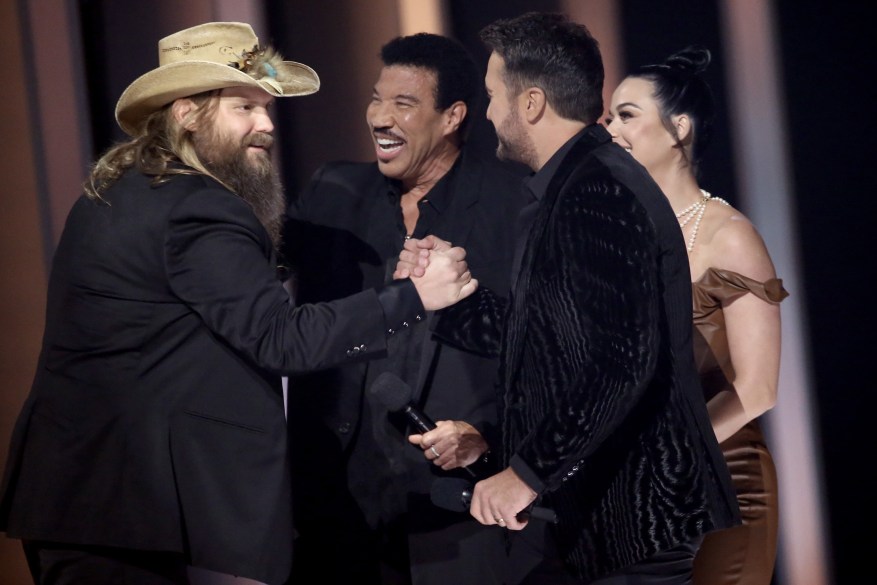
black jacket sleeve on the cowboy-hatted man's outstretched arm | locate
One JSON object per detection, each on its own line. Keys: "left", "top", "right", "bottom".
{"left": 165, "top": 188, "right": 423, "bottom": 374}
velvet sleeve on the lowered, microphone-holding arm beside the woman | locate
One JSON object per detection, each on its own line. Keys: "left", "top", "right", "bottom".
{"left": 511, "top": 172, "right": 661, "bottom": 490}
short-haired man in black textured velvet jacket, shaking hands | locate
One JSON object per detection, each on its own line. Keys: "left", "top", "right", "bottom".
{"left": 397, "top": 13, "right": 738, "bottom": 585}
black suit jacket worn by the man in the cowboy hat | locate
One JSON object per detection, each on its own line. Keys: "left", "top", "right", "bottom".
{"left": 0, "top": 171, "right": 422, "bottom": 583}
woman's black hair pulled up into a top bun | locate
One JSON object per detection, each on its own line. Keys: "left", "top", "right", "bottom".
{"left": 630, "top": 45, "right": 715, "bottom": 172}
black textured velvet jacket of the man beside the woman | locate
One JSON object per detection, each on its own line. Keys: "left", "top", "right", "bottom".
{"left": 435, "top": 126, "right": 738, "bottom": 581}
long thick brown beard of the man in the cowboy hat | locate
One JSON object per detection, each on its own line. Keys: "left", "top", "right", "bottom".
{"left": 192, "top": 126, "right": 286, "bottom": 250}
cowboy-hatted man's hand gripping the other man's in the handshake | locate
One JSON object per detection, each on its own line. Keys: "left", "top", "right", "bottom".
{"left": 411, "top": 240, "right": 478, "bottom": 311}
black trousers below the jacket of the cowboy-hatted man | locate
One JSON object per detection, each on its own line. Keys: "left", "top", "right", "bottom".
{"left": 23, "top": 541, "right": 189, "bottom": 585}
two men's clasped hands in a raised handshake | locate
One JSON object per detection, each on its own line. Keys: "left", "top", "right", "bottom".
{"left": 393, "top": 236, "right": 478, "bottom": 311}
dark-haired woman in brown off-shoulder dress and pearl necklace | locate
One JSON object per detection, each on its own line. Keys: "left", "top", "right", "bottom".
{"left": 606, "top": 47, "right": 788, "bottom": 585}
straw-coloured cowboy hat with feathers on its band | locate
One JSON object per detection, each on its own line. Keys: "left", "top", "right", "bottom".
{"left": 116, "top": 22, "right": 320, "bottom": 136}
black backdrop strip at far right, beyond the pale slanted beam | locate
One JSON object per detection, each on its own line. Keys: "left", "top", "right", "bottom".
{"left": 777, "top": 0, "right": 877, "bottom": 585}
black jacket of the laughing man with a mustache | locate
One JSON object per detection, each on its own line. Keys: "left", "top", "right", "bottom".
{"left": 285, "top": 148, "right": 523, "bottom": 528}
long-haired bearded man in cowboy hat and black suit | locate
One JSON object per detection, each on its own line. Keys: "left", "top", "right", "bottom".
{"left": 0, "top": 23, "right": 477, "bottom": 584}
